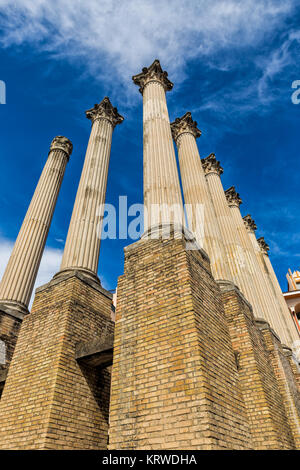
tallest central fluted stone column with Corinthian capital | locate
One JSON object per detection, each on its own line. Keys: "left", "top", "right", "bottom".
{"left": 132, "top": 60, "right": 183, "bottom": 232}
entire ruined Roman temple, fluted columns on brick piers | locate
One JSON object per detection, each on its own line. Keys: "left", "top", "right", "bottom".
{"left": 0, "top": 60, "right": 300, "bottom": 450}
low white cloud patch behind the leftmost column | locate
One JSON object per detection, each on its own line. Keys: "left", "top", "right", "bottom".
{"left": 0, "top": 238, "right": 62, "bottom": 307}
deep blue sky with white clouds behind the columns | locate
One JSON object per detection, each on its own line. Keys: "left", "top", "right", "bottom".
{"left": 0, "top": 0, "right": 300, "bottom": 300}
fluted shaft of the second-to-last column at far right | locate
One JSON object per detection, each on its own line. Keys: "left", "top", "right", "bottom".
{"left": 249, "top": 231, "right": 300, "bottom": 360}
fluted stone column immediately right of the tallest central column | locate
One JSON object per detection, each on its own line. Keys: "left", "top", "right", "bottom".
{"left": 171, "top": 112, "right": 231, "bottom": 280}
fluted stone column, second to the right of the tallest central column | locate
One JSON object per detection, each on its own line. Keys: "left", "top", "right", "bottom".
{"left": 201, "top": 153, "right": 262, "bottom": 317}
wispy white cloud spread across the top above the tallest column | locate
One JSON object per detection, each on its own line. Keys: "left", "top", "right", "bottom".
{"left": 0, "top": 0, "right": 297, "bottom": 89}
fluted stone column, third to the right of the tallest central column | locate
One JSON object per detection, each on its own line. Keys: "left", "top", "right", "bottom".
{"left": 225, "top": 186, "right": 279, "bottom": 328}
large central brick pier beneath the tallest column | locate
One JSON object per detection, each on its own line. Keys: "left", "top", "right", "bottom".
{"left": 109, "top": 239, "right": 251, "bottom": 449}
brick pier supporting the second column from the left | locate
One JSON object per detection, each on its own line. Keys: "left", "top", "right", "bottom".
{"left": 0, "top": 275, "right": 113, "bottom": 449}
